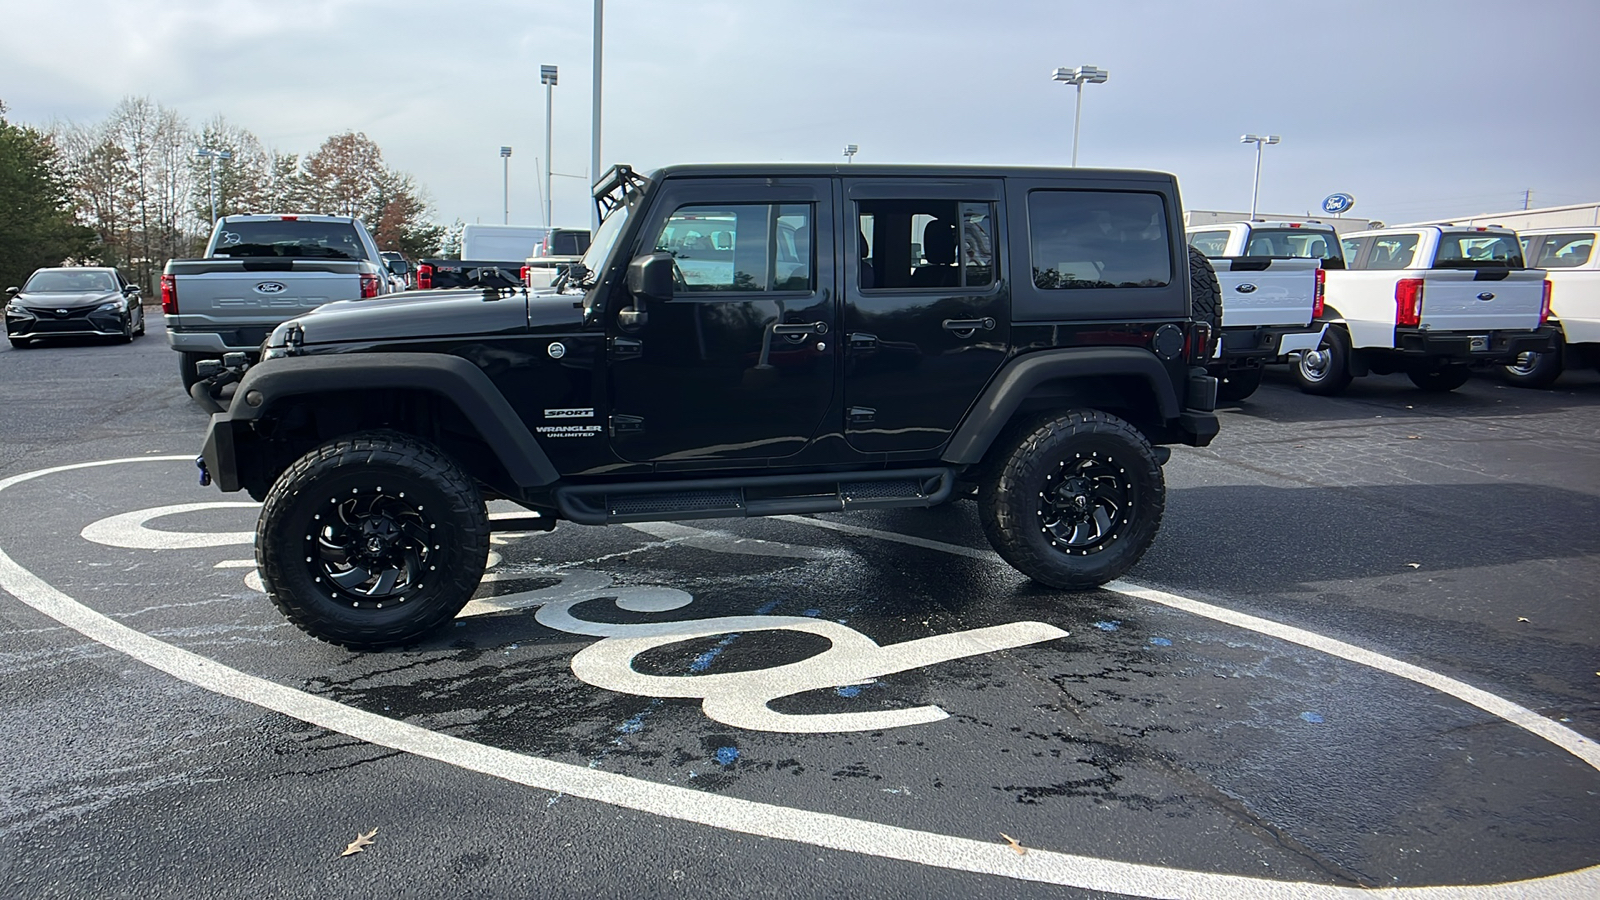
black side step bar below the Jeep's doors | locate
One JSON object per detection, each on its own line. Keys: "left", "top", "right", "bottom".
{"left": 555, "top": 468, "right": 955, "bottom": 525}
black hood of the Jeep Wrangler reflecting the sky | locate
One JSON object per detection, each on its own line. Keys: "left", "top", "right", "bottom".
{"left": 296, "top": 290, "right": 581, "bottom": 346}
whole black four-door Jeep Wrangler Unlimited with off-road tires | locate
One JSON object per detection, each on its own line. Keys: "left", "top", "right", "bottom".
{"left": 200, "top": 165, "right": 1219, "bottom": 649}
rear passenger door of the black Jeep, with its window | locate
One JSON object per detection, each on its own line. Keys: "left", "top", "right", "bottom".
{"left": 842, "top": 178, "right": 1010, "bottom": 453}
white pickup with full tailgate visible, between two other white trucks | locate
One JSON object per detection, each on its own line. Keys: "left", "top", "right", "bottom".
{"left": 1293, "top": 226, "right": 1555, "bottom": 394}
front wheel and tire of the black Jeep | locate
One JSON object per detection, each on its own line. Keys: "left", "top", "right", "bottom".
{"left": 256, "top": 431, "right": 490, "bottom": 650}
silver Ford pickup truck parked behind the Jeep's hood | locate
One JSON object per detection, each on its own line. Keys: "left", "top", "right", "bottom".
{"left": 162, "top": 216, "right": 394, "bottom": 391}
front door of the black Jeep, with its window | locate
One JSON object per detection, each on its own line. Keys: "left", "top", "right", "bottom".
{"left": 608, "top": 178, "right": 840, "bottom": 469}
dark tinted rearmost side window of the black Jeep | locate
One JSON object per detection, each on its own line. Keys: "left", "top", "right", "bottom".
{"left": 1027, "top": 191, "right": 1173, "bottom": 290}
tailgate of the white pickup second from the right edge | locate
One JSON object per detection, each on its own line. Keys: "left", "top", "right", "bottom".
{"left": 1421, "top": 269, "right": 1544, "bottom": 331}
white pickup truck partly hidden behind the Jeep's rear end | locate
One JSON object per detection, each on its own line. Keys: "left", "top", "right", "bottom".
{"left": 1189, "top": 221, "right": 1344, "bottom": 400}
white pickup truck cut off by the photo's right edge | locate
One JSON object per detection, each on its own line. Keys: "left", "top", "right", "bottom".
{"left": 1506, "top": 227, "right": 1600, "bottom": 388}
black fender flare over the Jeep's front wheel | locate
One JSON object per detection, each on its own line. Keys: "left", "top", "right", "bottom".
{"left": 208, "top": 352, "right": 562, "bottom": 488}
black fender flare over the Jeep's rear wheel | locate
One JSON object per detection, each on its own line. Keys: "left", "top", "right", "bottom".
{"left": 941, "top": 348, "right": 1181, "bottom": 466}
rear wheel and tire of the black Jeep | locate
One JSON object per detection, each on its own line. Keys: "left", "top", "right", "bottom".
{"left": 978, "top": 410, "right": 1166, "bottom": 591}
